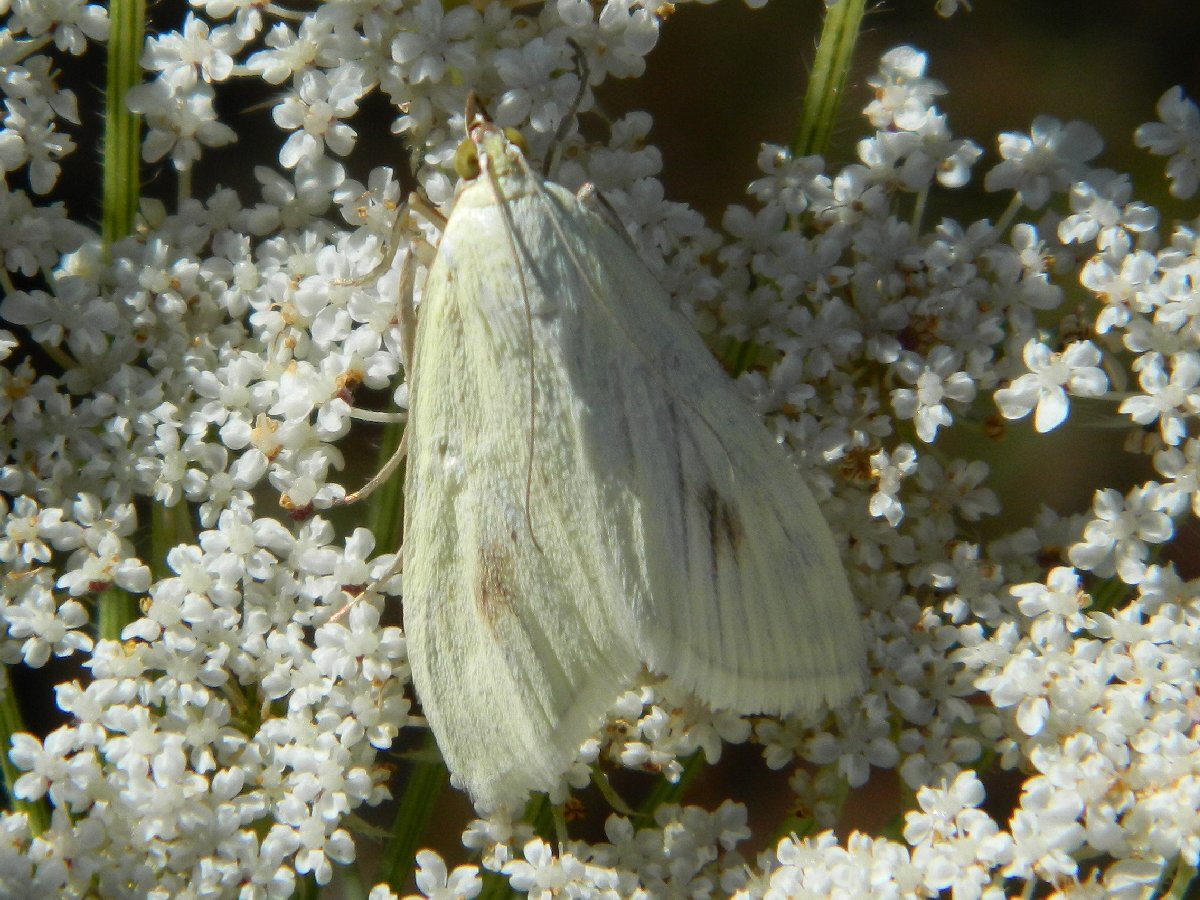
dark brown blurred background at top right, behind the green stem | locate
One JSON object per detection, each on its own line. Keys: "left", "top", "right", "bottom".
{"left": 604, "top": 0, "right": 1200, "bottom": 218}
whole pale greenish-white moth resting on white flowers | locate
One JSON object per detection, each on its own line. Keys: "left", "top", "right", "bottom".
{"left": 403, "top": 120, "right": 863, "bottom": 806}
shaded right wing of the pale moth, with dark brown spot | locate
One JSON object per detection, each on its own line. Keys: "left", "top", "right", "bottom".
{"left": 540, "top": 185, "right": 864, "bottom": 713}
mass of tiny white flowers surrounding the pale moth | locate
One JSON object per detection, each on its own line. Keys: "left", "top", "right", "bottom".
{"left": 0, "top": 0, "right": 1200, "bottom": 900}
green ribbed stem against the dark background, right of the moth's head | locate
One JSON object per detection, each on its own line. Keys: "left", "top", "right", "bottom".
{"left": 792, "top": 0, "right": 866, "bottom": 156}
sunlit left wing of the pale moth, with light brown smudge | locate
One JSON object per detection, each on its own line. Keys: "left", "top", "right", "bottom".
{"left": 404, "top": 185, "right": 640, "bottom": 806}
